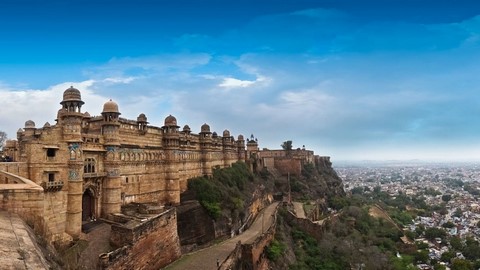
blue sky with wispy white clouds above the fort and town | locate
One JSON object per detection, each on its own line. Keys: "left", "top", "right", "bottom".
{"left": 0, "top": 0, "right": 480, "bottom": 161}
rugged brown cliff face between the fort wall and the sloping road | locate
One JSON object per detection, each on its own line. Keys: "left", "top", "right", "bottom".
{"left": 177, "top": 158, "right": 345, "bottom": 252}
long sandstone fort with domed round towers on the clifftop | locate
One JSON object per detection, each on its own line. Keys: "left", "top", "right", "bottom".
{"left": 0, "top": 87, "right": 330, "bottom": 269}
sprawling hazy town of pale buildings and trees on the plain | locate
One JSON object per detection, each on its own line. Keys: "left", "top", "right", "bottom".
{"left": 335, "top": 162, "right": 480, "bottom": 269}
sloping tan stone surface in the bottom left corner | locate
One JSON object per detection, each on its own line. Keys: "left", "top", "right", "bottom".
{"left": 0, "top": 211, "right": 50, "bottom": 270}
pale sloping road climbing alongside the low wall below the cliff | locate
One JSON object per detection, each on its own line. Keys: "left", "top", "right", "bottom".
{"left": 164, "top": 202, "right": 278, "bottom": 270}
